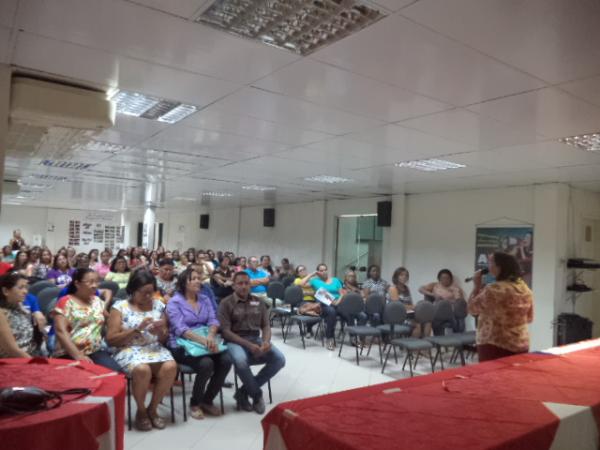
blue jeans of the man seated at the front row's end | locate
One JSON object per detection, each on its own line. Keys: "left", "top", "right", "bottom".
{"left": 227, "top": 337, "right": 285, "bottom": 400}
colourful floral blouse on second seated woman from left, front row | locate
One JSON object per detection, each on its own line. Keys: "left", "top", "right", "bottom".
{"left": 53, "top": 295, "right": 104, "bottom": 356}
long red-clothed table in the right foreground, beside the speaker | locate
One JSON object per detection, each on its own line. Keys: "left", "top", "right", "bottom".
{"left": 262, "top": 340, "right": 600, "bottom": 450}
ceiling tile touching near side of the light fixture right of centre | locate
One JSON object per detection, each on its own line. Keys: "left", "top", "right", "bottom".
{"left": 348, "top": 124, "right": 476, "bottom": 161}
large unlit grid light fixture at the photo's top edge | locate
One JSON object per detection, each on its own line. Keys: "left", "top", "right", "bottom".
{"left": 196, "top": 0, "right": 385, "bottom": 55}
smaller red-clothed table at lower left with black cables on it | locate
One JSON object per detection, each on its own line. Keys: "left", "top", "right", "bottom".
{"left": 0, "top": 358, "right": 126, "bottom": 450}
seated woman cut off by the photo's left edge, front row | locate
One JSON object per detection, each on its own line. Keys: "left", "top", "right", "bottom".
{"left": 0, "top": 274, "right": 39, "bottom": 358}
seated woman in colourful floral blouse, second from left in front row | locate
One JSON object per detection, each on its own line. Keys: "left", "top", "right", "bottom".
{"left": 52, "top": 269, "right": 121, "bottom": 371}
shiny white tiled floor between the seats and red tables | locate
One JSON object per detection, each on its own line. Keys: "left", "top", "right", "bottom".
{"left": 125, "top": 329, "right": 472, "bottom": 450}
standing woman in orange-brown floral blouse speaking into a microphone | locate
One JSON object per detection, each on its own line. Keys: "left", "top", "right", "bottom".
{"left": 469, "top": 252, "right": 533, "bottom": 362}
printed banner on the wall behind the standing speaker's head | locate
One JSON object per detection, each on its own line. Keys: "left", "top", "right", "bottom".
{"left": 475, "top": 226, "right": 533, "bottom": 287}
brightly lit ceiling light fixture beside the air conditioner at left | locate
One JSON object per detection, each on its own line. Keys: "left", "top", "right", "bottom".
{"left": 111, "top": 91, "right": 198, "bottom": 124}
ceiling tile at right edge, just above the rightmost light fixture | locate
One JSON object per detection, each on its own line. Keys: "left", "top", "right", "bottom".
{"left": 468, "top": 88, "right": 600, "bottom": 138}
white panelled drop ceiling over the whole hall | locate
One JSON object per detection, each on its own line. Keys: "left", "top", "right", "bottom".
{"left": 0, "top": 0, "right": 600, "bottom": 210}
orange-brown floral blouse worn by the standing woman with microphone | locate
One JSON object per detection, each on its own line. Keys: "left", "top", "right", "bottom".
{"left": 469, "top": 279, "right": 533, "bottom": 353}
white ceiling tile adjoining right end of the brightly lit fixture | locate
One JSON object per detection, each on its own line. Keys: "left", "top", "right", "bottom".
{"left": 181, "top": 106, "right": 332, "bottom": 145}
